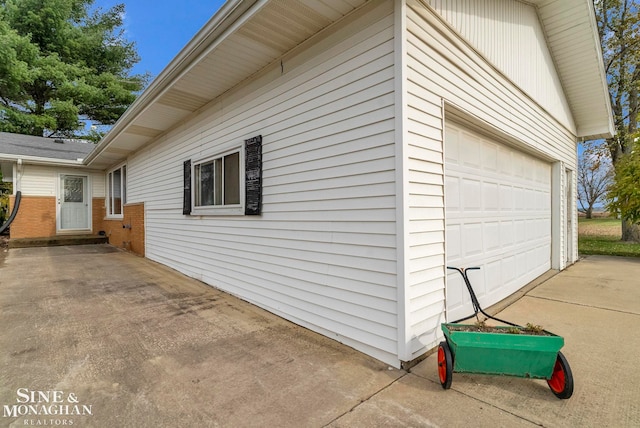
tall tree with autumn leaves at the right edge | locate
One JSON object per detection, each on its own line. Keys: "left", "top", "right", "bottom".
{"left": 594, "top": 0, "right": 640, "bottom": 241}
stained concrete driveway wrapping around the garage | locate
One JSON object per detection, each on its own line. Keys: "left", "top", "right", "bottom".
{"left": 0, "top": 245, "right": 640, "bottom": 427}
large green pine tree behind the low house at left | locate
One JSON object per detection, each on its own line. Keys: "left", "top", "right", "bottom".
{"left": 0, "top": 0, "right": 147, "bottom": 137}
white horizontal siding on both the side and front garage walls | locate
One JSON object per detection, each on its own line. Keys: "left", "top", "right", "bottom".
{"left": 117, "top": 0, "right": 576, "bottom": 366}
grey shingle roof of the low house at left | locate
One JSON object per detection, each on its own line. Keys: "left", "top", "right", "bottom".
{"left": 0, "top": 132, "right": 96, "bottom": 160}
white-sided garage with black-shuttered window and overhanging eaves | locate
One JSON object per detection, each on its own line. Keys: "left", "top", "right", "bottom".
{"left": 35, "top": 0, "right": 614, "bottom": 366}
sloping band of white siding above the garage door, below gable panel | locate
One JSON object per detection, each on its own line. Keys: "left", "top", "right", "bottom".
{"left": 408, "top": 0, "right": 576, "bottom": 160}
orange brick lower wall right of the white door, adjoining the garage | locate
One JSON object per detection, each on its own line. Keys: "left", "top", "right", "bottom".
{"left": 93, "top": 199, "right": 144, "bottom": 256}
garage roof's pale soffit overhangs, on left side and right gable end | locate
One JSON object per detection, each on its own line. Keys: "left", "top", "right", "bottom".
{"left": 86, "top": 0, "right": 614, "bottom": 169}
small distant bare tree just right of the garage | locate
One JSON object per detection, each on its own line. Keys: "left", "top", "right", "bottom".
{"left": 578, "top": 150, "right": 613, "bottom": 218}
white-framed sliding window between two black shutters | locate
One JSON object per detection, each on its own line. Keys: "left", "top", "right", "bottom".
{"left": 193, "top": 151, "right": 241, "bottom": 208}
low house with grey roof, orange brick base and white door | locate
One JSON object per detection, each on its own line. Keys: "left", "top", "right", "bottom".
{"left": 0, "top": 132, "right": 105, "bottom": 238}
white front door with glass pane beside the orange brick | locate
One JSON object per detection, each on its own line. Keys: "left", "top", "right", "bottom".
{"left": 58, "top": 174, "right": 91, "bottom": 231}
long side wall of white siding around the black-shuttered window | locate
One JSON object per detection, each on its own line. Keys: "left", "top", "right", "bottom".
{"left": 128, "top": 2, "right": 399, "bottom": 366}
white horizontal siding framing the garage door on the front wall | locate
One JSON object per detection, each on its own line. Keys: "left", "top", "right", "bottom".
{"left": 404, "top": 0, "right": 576, "bottom": 359}
